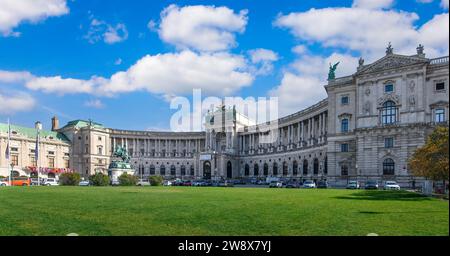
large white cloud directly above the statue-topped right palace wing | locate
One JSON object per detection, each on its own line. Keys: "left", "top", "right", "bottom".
{"left": 275, "top": 8, "right": 449, "bottom": 60}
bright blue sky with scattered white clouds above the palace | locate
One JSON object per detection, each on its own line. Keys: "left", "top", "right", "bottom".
{"left": 0, "top": 0, "right": 449, "bottom": 130}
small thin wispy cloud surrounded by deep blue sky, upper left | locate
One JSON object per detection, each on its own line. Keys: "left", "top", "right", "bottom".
{"left": 84, "top": 16, "right": 128, "bottom": 44}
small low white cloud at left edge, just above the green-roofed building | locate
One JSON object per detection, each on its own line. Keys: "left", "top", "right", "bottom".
{"left": 0, "top": 91, "right": 36, "bottom": 115}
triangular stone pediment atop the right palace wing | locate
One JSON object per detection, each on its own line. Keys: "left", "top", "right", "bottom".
{"left": 357, "top": 54, "right": 428, "bottom": 74}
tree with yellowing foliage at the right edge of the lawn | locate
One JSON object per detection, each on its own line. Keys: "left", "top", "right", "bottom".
{"left": 408, "top": 126, "right": 449, "bottom": 184}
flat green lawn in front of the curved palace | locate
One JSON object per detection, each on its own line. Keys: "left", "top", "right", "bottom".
{"left": 0, "top": 187, "right": 449, "bottom": 236}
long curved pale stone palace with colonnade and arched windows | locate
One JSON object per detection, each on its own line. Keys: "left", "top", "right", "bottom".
{"left": 0, "top": 45, "right": 449, "bottom": 187}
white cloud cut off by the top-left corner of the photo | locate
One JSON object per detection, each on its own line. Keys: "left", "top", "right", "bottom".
{"left": 0, "top": 0, "right": 69, "bottom": 36}
